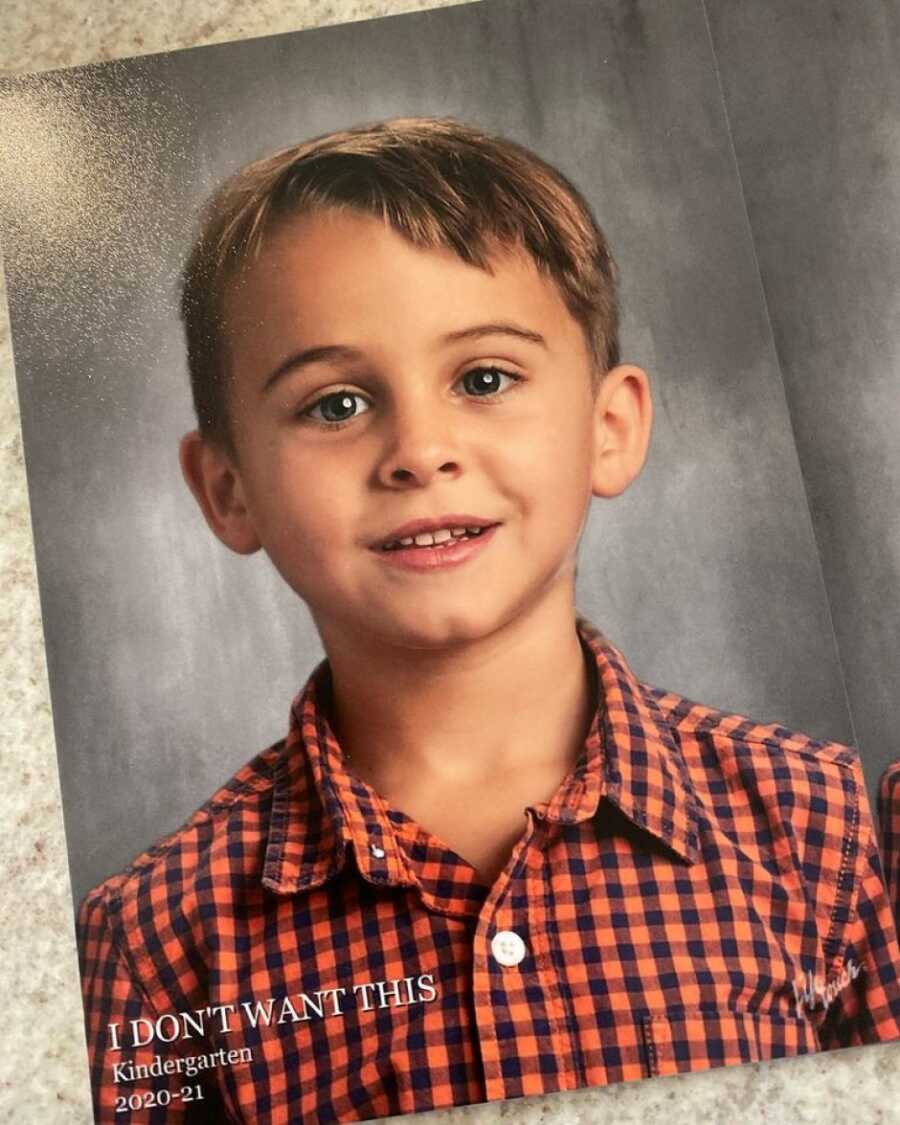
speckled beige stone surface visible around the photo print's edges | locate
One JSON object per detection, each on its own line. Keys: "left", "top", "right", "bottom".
{"left": 0, "top": 0, "right": 900, "bottom": 1125}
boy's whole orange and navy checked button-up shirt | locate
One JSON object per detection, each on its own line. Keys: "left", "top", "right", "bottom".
{"left": 80, "top": 623, "right": 900, "bottom": 1123}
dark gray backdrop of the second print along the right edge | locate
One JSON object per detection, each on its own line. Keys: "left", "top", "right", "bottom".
{"left": 708, "top": 0, "right": 900, "bottom": 814}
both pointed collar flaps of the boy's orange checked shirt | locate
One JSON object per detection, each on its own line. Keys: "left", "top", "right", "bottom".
{"left": 262, "top": 619, "right": 699, "bottom": 894}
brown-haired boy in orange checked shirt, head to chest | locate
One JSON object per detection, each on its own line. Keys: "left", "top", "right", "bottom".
{"left": 75, "top": 119, "right": 900, "bottom": 1123}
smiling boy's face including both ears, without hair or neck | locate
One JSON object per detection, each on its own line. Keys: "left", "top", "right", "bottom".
{"left": 182, "top": 212, "right": 649, "bottom": 648}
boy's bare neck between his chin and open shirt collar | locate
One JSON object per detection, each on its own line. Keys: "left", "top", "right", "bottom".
{"left": 323, "top": 583, "right": 596, "bottom": 801}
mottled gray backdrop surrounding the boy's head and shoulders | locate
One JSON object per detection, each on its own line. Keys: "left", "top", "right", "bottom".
{"left": 0, "top": 0, "right": 877, "bottom": 899}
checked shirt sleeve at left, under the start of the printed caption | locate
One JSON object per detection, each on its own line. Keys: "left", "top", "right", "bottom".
{"left": 78, "top": 891, "right": 226, "bottom": 1125}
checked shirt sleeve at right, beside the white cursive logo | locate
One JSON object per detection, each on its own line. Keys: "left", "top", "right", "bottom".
{"left": 819, "top": 814, "right": 900, "bottom": 1051}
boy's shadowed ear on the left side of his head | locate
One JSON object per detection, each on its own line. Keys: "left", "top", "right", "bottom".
{"left": 178, "top": 430, "right": 262, "bottom": 555}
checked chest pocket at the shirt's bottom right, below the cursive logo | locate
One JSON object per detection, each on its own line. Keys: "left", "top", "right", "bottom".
{"left": 642, "top": 1008, "right": 820, "bottom": 1078}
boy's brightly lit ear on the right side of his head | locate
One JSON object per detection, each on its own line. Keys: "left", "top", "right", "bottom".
{"left": 592, "top": 363, "right": 654, "bottom": 500}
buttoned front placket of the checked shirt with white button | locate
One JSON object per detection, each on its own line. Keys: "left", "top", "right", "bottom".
{"left": 473, "top": 809, "right": 579, "bottom": 1101}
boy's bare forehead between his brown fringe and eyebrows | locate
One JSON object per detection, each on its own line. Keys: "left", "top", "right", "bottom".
{"left": 224, "top": 210, "right": 581, "bottom": 362}
